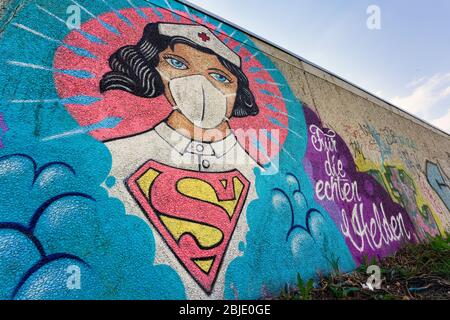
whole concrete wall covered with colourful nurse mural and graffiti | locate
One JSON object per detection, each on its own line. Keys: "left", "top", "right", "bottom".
{"left": 0, "top": 0, "right": 450, "bottom": 299}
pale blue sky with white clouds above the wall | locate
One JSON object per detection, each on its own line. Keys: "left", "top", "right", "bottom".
{"left": 186, "top": 0, "right": 450, "bottom": 134}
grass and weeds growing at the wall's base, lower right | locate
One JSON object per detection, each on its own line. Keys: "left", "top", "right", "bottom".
{"left": 277, "top": 237, "right": 450, "bottom": 300}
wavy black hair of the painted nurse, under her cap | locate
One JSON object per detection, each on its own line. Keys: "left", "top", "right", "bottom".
{"left": 100, "top": 23, "right": 259, "bottom": 118}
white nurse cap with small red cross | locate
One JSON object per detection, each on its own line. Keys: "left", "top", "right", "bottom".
{"left": 158, "top": 23, "right": 241, "bottom": 67}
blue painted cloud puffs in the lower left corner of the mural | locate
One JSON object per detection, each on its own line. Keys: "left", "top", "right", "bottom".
{"left": 0, "top": 154, "right": 185, "bottom": 299}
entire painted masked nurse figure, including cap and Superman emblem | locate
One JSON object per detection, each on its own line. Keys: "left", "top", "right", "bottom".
{"left": 100, "top": 23, "right": 259, "bottom": 294}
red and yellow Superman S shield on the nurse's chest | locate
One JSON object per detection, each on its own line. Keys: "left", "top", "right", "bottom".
{"left": 128, "top": 161, "right": 250, "bottom": 293}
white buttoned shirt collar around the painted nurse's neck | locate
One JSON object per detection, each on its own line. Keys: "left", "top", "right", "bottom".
{"left": 155, "top": 122, "right": 238, "bottom": 158}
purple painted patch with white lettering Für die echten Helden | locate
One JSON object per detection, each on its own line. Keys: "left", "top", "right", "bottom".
{"left": 304, "top": 107, "right": 417, "bottom": 262}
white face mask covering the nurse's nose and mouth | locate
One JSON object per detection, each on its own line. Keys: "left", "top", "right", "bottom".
{"left": 162, "top": 75, "right": 235, "bottom": 129}
